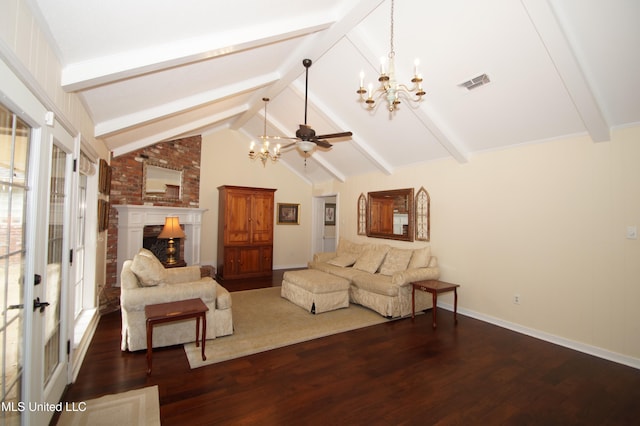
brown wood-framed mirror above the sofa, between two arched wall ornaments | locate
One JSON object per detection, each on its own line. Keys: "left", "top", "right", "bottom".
{"left": 367, "top": 188, "right": 415, "bottom": 241}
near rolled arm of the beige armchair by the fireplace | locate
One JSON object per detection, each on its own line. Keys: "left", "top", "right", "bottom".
{"left": 121, "top": 278, "right": 216, "bottom": 311}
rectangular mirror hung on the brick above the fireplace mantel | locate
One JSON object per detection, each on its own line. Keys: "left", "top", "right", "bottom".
{"left": 142, "top": 161, "right": 183, "bottom": 201}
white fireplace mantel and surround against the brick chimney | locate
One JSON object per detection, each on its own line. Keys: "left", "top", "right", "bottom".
{"left": 113, "top": 204, "right": 207, "bottom": 287}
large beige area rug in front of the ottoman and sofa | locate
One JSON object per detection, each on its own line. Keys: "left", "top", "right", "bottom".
{"left": 184, "top": 287, "right": 388, "bottom": 368}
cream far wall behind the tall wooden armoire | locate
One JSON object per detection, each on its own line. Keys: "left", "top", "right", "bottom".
{"left": 200, "top": 130, "right": 312, "bottom": 269}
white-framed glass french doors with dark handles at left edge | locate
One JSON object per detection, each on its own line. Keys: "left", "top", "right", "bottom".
{"left": 0, "top": 58, "right": 74, "bottom": 425}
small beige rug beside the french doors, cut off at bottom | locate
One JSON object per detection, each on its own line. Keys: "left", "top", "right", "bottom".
{"left": 57, "top": 386, "right": 160, "bottom": 426}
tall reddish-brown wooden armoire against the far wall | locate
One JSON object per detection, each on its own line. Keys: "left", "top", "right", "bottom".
{"left": 217, "top": 185, "right": 276, "bottom": 280}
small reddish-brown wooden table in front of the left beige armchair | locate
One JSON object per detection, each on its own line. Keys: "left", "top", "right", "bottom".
{"left": 144, "top": 299, "right": 209, "bottom": 374}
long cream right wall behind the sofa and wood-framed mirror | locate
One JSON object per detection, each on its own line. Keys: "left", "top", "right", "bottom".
{"left": 322, "top": 128, "right": 640, "bottom": 368}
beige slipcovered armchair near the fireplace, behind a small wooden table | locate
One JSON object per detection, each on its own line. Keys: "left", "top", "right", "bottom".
{"left": 120, "top": 249, "right": 233, "bottom": 351}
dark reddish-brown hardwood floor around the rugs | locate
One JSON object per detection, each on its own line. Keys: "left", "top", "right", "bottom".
{"left": 54, "top": 271, "right": 640, "bottom": 425}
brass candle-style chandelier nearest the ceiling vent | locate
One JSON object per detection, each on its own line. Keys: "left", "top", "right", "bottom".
{"left": 356, "top": 0, "right": 425, "bottom": 112}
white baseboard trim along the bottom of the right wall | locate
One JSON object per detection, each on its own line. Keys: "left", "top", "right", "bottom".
{"left": 438, "top": 302, "right": 640, "bottom": 370}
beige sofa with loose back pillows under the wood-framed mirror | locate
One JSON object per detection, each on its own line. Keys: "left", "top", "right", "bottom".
{"left": 309, "top": 239, "right": 440, "bottom": 318}
